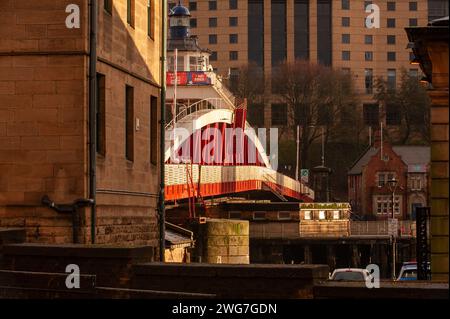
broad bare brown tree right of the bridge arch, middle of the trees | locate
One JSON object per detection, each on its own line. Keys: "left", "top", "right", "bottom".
{"left": 272, "top": 60, "right": 360, "bottom": 175}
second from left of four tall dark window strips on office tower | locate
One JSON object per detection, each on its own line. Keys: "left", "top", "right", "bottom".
{"left": 271, "top": 0, "right": 287, "bottom": 66}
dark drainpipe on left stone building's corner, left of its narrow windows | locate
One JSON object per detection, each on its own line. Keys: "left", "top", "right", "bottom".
{"left": 89, "top": 0, "right": 97, "bottom": 244}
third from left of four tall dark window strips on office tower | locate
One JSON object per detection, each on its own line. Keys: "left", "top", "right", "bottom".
{"left": 294, "top": 0, "right": 309, "bottom": 59}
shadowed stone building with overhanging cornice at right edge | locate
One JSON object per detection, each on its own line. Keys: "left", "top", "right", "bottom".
{"left": 406, "top": 16, "right": 449, "bottom": 282}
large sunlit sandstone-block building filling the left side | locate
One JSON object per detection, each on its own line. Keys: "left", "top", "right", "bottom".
{"left": 0, "top": 0, "right": 163, "bottom": 254}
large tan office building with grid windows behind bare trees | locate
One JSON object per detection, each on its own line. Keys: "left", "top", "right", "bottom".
{"left": 169, "top": 0, "right": 448, "bottom": 130}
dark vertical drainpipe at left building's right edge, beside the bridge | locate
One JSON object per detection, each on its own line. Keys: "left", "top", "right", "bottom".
{"left": 158, "top": 0, "right": 167, "bottom": 262}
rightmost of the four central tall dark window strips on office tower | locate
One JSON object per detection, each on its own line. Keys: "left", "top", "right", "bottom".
{"left": 317, "top": 0, "right": 332, "bottom": 65}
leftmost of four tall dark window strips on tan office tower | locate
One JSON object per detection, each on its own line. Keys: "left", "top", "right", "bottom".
{"left": 248, "top": 0, "right": 264, "bottom": 67}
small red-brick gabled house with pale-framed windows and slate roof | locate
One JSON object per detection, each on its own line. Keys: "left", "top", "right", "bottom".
{"left": 348, "top": 134, "right": 430, "bottom": 219}
